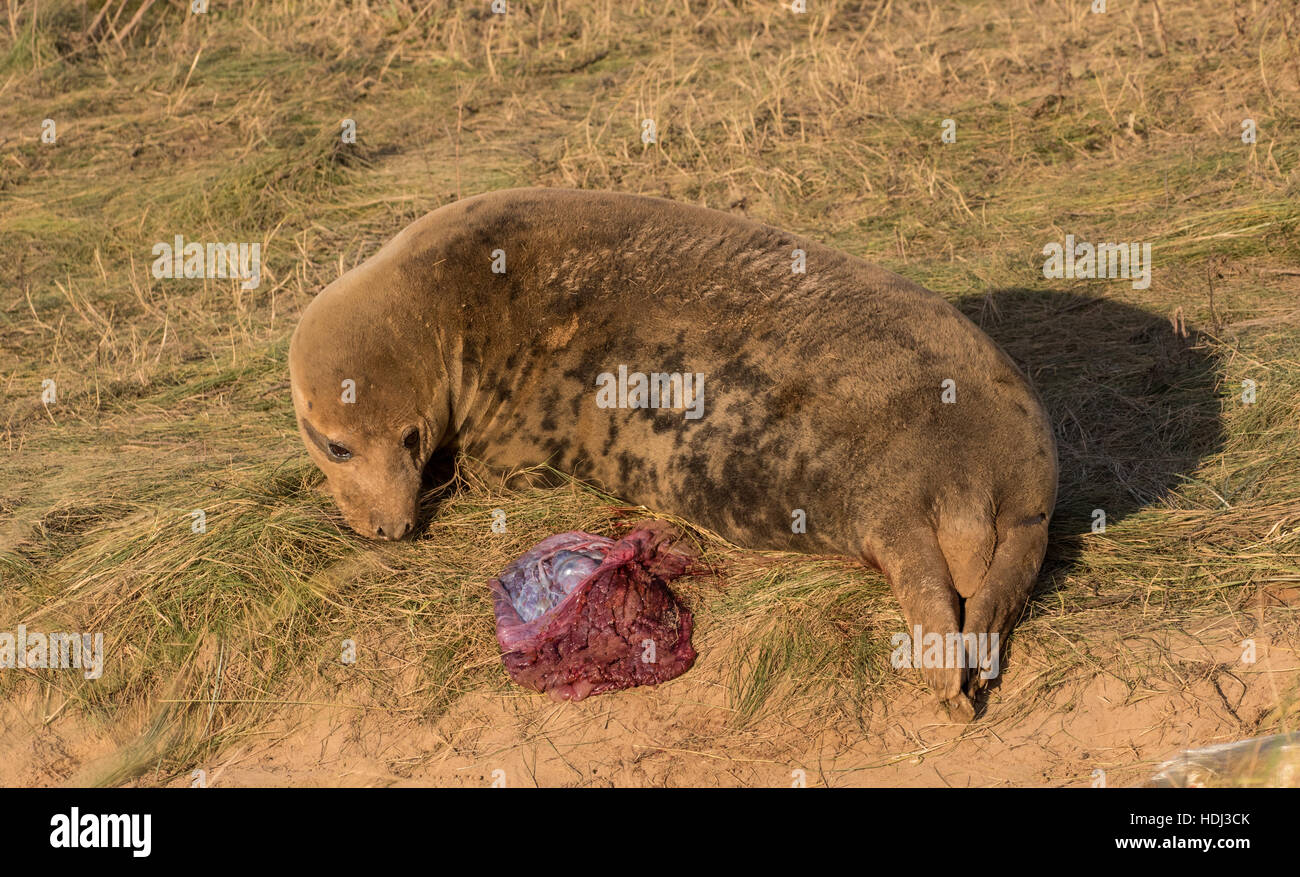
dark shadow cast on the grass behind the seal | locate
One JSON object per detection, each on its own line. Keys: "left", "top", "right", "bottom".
{"left": 957, "top": 288, "right": 1223, "bottom": 592}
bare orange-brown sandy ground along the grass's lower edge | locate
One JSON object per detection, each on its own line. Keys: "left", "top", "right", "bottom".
{"left": 0, "top": 597, "right": 1300, "bottom": 787}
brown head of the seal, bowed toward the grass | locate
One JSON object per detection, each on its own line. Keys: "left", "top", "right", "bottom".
{"left": 289, "top": 265, "right": 447, "bottom": 539}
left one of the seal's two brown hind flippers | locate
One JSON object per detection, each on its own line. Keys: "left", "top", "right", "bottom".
{"left": 868, "top": 525, "right": 975, "bottom": 722}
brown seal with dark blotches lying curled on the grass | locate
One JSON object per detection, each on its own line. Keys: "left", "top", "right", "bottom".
{"left": 290, "top": 190, "right": 1057, "bottom": 717}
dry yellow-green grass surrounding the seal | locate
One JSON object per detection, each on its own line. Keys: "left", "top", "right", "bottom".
{"left": 0, "top": 0, "right": 1300, "bottom": 782}
